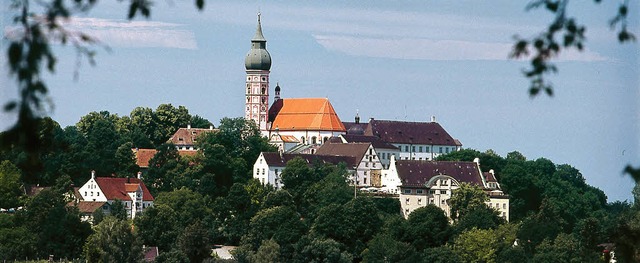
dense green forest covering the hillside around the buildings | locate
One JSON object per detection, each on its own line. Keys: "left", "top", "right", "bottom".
{"left": 0, "top": 104, "right": 640, "bottom": 262}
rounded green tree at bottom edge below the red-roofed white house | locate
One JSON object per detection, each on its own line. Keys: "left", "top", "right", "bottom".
{"left": 84, "top": 217, "right": 142, "bottom": 263}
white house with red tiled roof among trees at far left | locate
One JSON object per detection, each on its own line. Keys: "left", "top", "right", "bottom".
{"left": 76, "top": 171, "right": 154, "bottom": 219}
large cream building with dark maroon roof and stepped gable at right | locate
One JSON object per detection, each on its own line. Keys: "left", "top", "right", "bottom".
{"left": 383, "top": 157, "right": 509, "bottom": 221}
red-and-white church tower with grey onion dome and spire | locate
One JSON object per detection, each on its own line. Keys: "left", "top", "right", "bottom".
{"left": 244, "top": 13, "right": 271, "bottom": 134}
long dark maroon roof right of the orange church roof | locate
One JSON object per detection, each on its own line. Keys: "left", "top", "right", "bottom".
{"left": 364, "top": 120, "right": 460, "bottom": 146}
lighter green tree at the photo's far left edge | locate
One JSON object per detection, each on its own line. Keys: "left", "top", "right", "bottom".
{"left": 0, "top": 160, "right": 22, "bottom": 209}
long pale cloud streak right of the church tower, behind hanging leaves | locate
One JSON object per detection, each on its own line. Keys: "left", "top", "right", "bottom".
{"left": 314, "top": 35, "right": 607, "bottom": 61}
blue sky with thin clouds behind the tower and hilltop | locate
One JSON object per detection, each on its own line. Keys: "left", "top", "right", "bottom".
{"left": 0, "top": 0, "right": 640, "bottom": 201}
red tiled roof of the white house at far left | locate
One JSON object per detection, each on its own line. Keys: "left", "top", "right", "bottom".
{"left": 96, "top": 177, "right": 154, "bottom": 201}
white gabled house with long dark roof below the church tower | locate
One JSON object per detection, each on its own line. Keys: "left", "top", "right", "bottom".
{"left": 253, "top": 152, "right": 358, "bottom": 189}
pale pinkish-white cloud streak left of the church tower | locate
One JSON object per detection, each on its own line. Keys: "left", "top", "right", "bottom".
{"left": 65, "top": 18, "right": 198, "bottom": 49}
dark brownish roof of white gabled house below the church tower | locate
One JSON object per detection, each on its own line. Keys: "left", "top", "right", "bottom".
{"left": 262, "top": 152, "right": 359, "bottom": 168}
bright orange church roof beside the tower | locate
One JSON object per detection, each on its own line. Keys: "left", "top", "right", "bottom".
{"left": 269, "top": 98, "right": 346, "bottom": 132}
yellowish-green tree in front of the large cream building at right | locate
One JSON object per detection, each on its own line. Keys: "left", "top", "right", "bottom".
{"left": 449, "top": 183, "right": 489, "bottom": 219}
